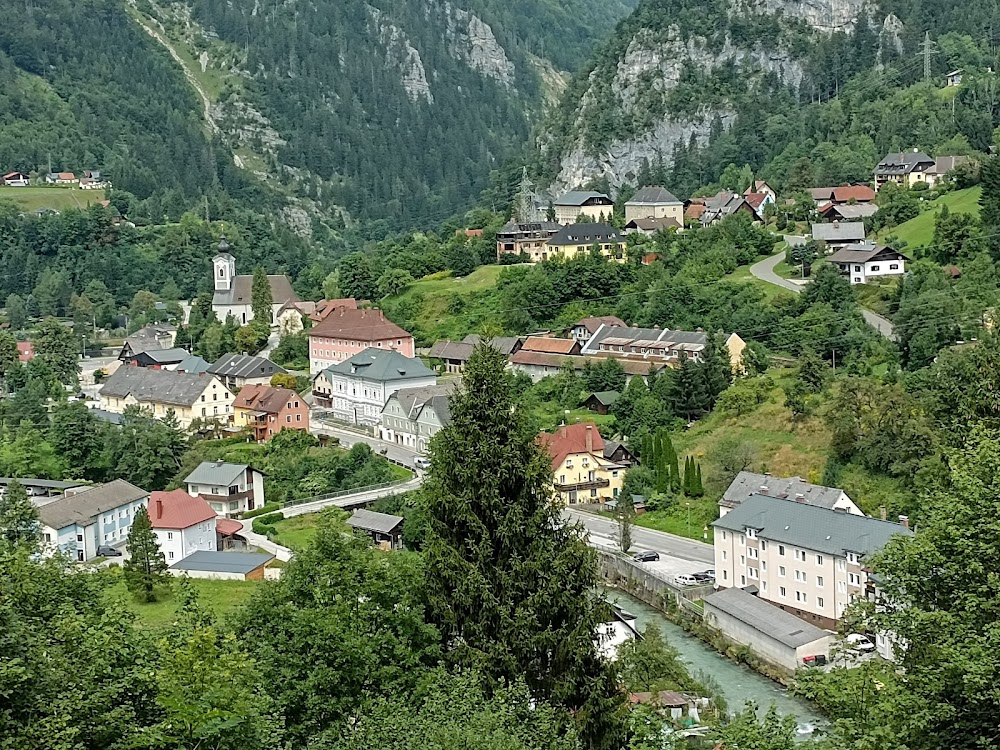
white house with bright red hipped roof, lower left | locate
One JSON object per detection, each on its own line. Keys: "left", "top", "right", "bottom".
{"left": 149, "top": 489, "right": 217, "bottom": 565}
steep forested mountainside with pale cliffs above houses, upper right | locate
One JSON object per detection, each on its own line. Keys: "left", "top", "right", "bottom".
{"left": 540, "top": 0, "right": 1000, "bottom": 194}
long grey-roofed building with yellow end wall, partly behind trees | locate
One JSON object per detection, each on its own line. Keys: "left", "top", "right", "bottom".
{"left": 583, "top": 326, "right": 746, "bottom": 372}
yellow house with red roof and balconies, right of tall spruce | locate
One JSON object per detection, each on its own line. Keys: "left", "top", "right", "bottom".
{"left": 538, "top": 422, "right": 627, "bottom": 505}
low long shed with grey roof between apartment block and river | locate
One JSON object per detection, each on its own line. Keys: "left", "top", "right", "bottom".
{"left": 702, "top": 588, "right": 835, "bottom": 672}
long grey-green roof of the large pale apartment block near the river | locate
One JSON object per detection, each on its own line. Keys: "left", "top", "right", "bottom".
{"left": 712, "top": 495, "right": 912, "bottom": 556}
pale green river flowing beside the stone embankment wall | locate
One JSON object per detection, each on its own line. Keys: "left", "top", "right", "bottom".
{"left": 608, "top": 589, "right": 825, "bottom": 739}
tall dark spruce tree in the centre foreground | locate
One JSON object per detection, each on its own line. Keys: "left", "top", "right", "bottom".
{"left": 422, "top": 344, "right": 624, "bottom": 748}
